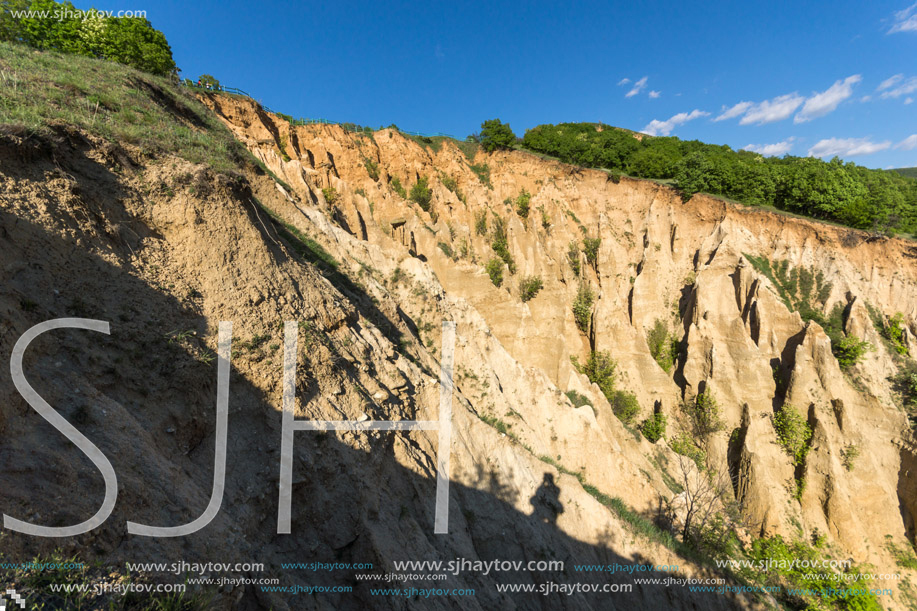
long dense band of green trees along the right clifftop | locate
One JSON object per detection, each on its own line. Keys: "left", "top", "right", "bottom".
{"left": 522, "top": 123, "right": 917, "bottom": 233}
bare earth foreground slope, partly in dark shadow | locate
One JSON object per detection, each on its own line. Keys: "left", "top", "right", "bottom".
{"left": 0, "top": 126, "right": 754, "bottom": 609}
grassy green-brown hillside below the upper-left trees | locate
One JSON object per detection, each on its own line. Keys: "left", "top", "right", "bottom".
{"left": 0, "top": 42, "right": 249, "bottom": 172}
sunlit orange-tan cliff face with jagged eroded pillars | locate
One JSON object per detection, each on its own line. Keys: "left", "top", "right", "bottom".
{"left": 205, "top": 96, "right": 917, "bottom": 605}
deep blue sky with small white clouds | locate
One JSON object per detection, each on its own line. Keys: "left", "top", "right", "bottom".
{"left": 91, "top": 0, "right": 917, "bottom": 167}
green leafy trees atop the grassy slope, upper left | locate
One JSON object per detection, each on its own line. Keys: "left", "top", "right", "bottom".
{"left": 0, "top": 0, "right": 177, "bottom": 76}
